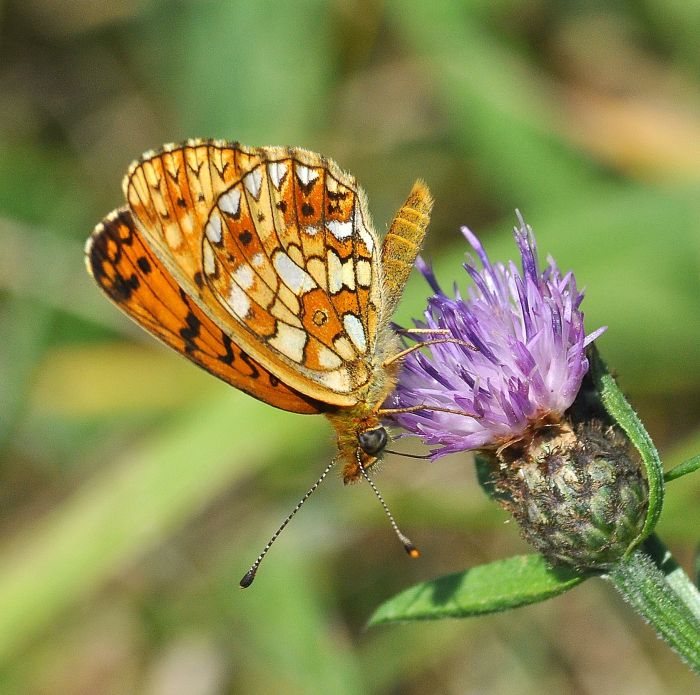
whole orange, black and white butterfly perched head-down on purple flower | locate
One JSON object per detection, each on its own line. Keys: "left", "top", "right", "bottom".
{"left": 85, "top": 140, "right": 433, "bottom": 586}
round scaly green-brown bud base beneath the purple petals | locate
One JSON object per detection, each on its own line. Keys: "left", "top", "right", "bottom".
{"left": 487, "top": 420, "right": 649, "bottom": 570}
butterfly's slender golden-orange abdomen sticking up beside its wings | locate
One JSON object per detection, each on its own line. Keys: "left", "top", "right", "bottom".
{"left": 382, "top": 180, "right": 433, "bottom": 315}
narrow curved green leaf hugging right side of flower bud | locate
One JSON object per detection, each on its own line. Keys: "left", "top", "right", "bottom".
{"left": 588, "top": 345, "right": 664, "bottom": 550}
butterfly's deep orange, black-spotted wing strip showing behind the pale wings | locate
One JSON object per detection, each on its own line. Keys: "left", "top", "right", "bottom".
{"left": 85, "top": 208, "right": 326, "bottom": 413}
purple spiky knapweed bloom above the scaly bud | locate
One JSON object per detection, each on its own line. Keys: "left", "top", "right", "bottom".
{"left": 386, "top": 213, "right": 605, "bottom": 458}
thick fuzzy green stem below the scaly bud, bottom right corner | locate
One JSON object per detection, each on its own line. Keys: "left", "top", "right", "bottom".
{"left": 605, "top": 538, "right": 700, "bottom": 674}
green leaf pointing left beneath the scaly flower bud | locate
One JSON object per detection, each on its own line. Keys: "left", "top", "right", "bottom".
{"left": 368, "top": 555, "right": 590, "bottom": 625}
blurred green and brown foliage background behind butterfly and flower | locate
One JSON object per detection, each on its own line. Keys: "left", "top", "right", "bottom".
{"left": 0, "top": 0, "right": 700, "bottom": 695}
